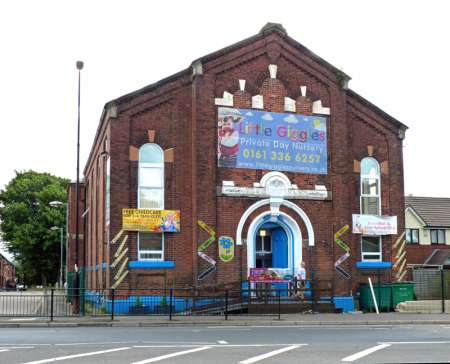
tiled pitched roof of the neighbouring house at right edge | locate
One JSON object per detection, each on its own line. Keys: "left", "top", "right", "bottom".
{"left": 405, "top": 196, "right": 450, "bottom": 227}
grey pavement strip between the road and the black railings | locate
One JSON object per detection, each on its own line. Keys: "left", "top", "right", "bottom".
{"left": 0, "top": 312, "right": 450, "bottom": 328}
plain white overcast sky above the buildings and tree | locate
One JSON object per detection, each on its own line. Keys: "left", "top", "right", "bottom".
{"left": 0, "top": 0, "right": 450, "bottom": 256}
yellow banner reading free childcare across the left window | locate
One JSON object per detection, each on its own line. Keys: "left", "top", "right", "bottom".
{"left": 122, "top": 209, "right": 180, "bottom": 233}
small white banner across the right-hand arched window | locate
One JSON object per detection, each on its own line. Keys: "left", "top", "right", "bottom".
{"left": 353, "top": 215, "right": 397, "bottom": 235}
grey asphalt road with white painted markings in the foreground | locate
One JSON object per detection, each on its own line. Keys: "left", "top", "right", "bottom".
{"left": 0, "top": 325, "right": 450, "bottom": 364}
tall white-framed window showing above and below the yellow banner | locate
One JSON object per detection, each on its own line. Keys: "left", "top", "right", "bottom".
{"left": 138, "top": 143, "right": 164, "bottom": 260}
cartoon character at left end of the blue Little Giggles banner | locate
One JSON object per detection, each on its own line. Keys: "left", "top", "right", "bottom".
{"left": 218, "top": 115, "right": 242, "bottom": 167}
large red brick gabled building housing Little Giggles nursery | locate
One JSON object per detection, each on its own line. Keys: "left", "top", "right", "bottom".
{"left": 70, "top": 23, "right": 406, "bottom": 302}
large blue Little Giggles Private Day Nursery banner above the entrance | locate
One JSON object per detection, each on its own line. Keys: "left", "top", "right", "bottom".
{"left": 217, "top": 107, "right": 327, "bottom": 174}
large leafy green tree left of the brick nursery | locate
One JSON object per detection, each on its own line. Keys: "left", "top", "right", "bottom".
{"left": 0, "top": 171, "right": 69, "bottom": 285}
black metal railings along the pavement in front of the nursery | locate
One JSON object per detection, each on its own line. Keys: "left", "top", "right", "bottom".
{"left": 0, "top": 283, "right": 334, "bottom": 320}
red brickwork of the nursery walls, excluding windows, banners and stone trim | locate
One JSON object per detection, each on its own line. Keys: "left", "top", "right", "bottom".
{"left": 77, "top": 26, "right": 406, "bottom": 294}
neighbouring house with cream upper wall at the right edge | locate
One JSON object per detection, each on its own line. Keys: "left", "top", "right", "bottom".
{"left": 405, "top": 196, "right": 450, "bottom": 264}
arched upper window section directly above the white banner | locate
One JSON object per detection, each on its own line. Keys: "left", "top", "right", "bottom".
{"left": 360, "top": 157, "right": 381, "bottom": 215}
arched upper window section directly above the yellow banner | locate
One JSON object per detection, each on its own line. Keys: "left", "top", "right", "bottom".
{"left": 138, "top": 143, "right": 164, "bottom": 209}
